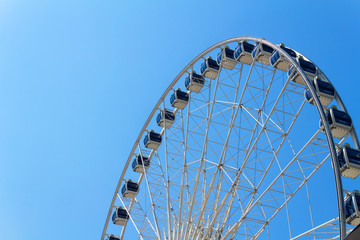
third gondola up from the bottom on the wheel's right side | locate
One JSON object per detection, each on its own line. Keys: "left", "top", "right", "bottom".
{"left": 319, "top": 106, "right": 352, "bottom": 139}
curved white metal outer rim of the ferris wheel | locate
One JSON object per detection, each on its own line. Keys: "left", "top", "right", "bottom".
{"left": 101, "top": 37, "right": 357, "bottom": 239}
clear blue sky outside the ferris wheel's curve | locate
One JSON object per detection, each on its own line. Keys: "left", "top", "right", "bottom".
{"left": 0, "top": 0, "right": 360, "bottom": 240}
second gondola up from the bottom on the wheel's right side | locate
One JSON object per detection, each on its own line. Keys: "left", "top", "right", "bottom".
{"left": 338, "top": 144, "right": 360, "bottom": 179}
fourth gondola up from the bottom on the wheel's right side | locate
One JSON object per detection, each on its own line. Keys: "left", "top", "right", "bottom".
{"left": 305, "top": 76, "right": 335, "bottom": 107}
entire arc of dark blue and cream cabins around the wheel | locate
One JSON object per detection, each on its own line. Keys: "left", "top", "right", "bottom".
{"left": 108, "top": 41, "right": 360, "bottom": 236}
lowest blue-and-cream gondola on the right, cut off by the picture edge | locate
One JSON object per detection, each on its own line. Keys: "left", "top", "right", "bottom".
{"left": 345, "top": 190, "right": 360, "bottom": 226}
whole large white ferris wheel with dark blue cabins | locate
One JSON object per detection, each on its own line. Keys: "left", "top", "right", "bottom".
{"left": 101, "top": 37, "right": 360, "bottom": 240}
